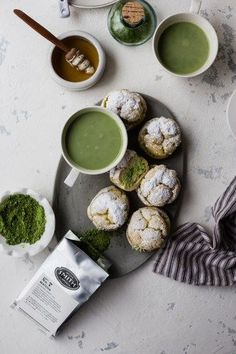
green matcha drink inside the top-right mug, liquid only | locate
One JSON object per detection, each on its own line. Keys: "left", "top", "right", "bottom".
{"left": 158, "top": 22, "right": 209, "bottom": 75}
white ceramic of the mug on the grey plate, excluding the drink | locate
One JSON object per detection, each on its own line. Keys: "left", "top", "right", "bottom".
{"left": 61, "top": 106, "right": 128, "bottom": 187}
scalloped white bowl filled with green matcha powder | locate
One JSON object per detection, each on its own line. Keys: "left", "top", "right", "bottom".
{"left": 0, "top": 188, "right": 55, "bottom": 257}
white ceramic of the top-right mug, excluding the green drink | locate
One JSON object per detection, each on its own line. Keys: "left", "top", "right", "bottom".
{"left": 152, "top": 0, "right": 218, "bottom": 77}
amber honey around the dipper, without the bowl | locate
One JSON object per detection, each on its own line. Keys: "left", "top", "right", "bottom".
{"left": 52, "top": 36, "right": 99, "bottom": 82}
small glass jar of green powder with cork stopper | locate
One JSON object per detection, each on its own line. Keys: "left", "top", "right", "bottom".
{"left": 108, "top": 0, "right": 157, "bottom": 46}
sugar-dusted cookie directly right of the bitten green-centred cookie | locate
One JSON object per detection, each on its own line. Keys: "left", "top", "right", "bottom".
{"left": 137, "top": 165, "right": 181, "bottom": 207}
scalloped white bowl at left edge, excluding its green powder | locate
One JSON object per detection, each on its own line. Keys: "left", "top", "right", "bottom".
{"left": 0, "top": 188, "right": 55, "bottom": 257}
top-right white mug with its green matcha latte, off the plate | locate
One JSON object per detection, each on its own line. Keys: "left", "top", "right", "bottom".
{"left": 153, "top": 0, "right": 218, "bottom": 77}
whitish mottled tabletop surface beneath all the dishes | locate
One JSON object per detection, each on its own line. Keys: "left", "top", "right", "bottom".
{"left": 0, "top": 0, "right": 236, "bottom": 354}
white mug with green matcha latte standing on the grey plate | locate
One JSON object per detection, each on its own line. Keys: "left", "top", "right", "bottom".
{"left": 61, "top": 106, "right": 128, "bottom": 187}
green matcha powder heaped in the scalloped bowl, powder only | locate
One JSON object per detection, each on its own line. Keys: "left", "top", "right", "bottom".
{"left": 0, "top": 194, "right": 46, "bottom": 245}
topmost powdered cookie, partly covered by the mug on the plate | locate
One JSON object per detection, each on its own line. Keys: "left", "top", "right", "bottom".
{"left": 102, "top": 89, "right": 147, "bottom": 129}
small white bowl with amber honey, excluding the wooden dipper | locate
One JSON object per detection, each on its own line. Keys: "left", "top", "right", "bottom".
{"left": 49, "top": 31, "right": 106, "bottom": 91}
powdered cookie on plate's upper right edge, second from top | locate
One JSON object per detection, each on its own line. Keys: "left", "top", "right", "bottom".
{"left": 138, "top": 117, "right": 181, "bottom": 159}
